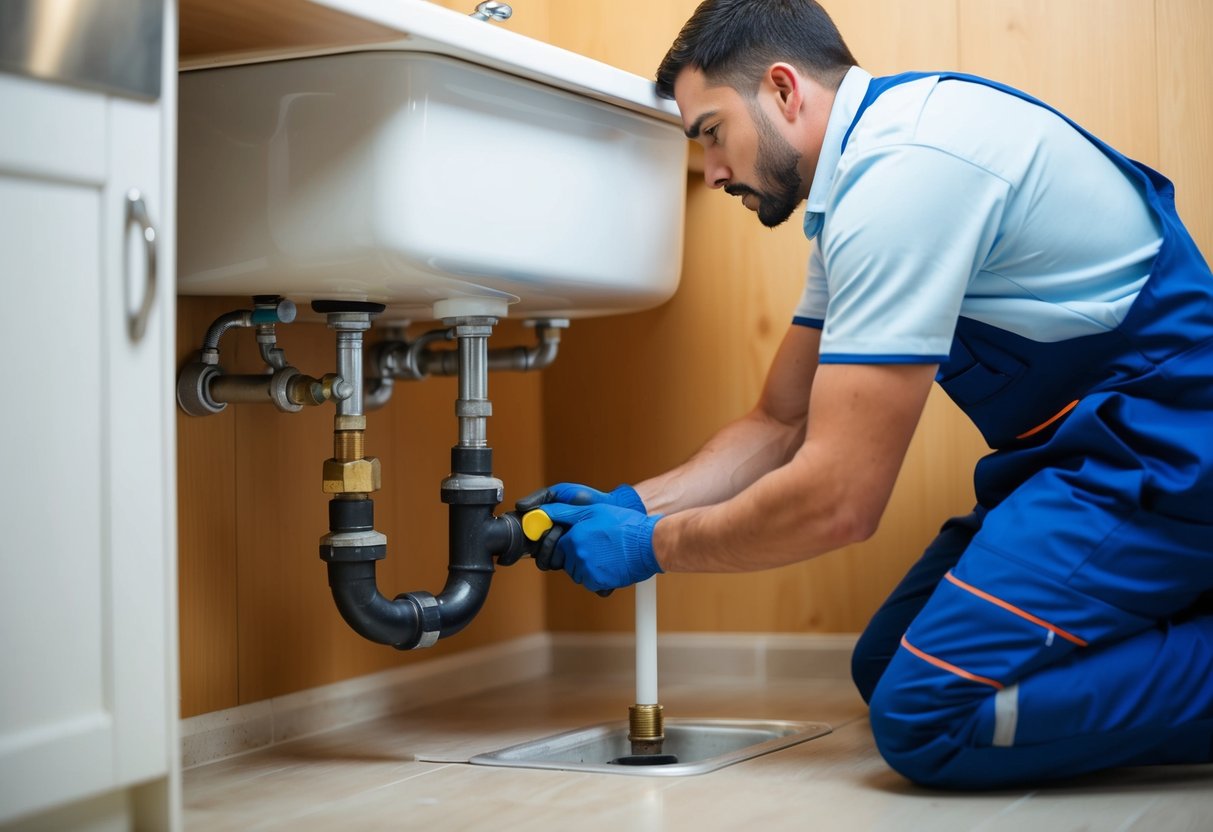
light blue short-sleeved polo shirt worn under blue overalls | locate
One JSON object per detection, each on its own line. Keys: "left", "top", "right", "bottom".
{"left": 793, "top": 67, "right": 1161, "bottom": 364}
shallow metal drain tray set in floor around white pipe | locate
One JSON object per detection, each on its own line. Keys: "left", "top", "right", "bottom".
{"left": 469, "top": 719, "right": 831, "bottom": 776}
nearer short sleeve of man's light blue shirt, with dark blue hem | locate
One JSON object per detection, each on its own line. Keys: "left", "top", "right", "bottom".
{"left": 819, "top": 144, "right": 1009, "bottom": 364}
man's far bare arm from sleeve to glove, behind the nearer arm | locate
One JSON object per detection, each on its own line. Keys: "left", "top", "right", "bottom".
{"left": 636, "top": 326, "right": 821, "bottom": 514}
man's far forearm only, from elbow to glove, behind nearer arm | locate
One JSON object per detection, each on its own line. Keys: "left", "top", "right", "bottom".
{"left": 636, "top": 410, "right": 804, "bottom": 514}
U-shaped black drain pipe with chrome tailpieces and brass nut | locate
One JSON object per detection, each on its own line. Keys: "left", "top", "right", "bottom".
{"left": 313, "top": 302, "right": 524, "bottom": 650}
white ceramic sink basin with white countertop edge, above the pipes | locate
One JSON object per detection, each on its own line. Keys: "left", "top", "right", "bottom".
{"left": 177, "top": 0, "right": 687, "bottom": 319}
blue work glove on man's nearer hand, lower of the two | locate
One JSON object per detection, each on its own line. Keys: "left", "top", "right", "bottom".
{"left": 543, "top": 503, "right": 662, "bottom": 592}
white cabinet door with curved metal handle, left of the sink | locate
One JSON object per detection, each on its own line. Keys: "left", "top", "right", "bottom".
{"left": 0, "top": 34, "right": 178, "bottom": 828}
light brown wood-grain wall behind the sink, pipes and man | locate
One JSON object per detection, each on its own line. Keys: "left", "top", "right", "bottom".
{"left": 178, "top": 0, "right": 1213, "bottom": 716}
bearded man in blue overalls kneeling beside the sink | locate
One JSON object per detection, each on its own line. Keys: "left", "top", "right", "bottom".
{"left": 519, "top": 0, "right": 1213, "bottom": 788}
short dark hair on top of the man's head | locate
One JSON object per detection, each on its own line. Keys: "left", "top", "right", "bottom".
{"left": 657, "top": 0, "right": 855, "bottom": 98}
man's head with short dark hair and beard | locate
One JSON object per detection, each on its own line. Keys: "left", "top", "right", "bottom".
{"left": 657, "top": 0, "right": 855, "bottom": 226}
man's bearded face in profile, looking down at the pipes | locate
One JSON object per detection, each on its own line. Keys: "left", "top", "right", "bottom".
{"left": 674, "top": 69, "right": 808, "bottom": 228}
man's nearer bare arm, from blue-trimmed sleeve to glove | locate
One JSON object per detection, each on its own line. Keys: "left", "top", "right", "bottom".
{"left": 653, "top": 364, "right": 935, "bottom": 571}
